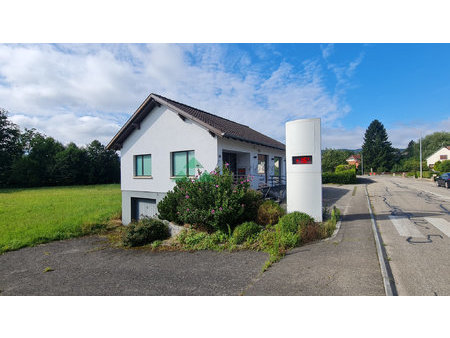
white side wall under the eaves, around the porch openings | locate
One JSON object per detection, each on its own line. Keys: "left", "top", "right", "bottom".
{"left": 217, "top": 138, "right": 286, "bottom": 189}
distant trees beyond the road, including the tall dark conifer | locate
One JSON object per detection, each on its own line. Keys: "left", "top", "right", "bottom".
{"left": 322, "top": 120, "right": 450, "bottom": 173}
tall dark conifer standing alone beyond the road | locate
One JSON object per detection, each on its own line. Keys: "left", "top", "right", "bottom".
{"left": 362, "top": 120, "right": 395, "bottom": 171}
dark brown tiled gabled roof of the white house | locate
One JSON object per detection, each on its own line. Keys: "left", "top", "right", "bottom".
{"left": 107, "top": 94, "right": 285, "bottom": 150}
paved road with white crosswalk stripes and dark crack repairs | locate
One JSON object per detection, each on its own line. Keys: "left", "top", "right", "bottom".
{"left": 368, "top": 176, "right": 450, "bottom": 295}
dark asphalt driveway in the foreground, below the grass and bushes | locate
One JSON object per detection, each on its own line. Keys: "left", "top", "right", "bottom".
{"left": 0, "top": 236, "right": 268, "bottom": 296}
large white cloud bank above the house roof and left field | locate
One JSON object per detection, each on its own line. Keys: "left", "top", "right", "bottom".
{"left": 0, "top": 44, "right": 362, "bottom": 147}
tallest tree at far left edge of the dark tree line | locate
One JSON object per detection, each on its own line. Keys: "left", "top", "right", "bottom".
{"left": 0, "top": 108, "right": 22, "bottom": 187}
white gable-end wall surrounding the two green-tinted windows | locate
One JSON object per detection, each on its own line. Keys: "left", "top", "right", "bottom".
{"left": 121, "top": 106, "right": 217, "bottom": 192}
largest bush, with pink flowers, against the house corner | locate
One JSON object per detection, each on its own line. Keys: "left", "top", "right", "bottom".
{"left": 158, "top": 166, "right": 261, "bottom": 232}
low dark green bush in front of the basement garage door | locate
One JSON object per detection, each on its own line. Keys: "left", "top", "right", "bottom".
{"left": 123, "top": 217, "right": 170, "bottom": 246}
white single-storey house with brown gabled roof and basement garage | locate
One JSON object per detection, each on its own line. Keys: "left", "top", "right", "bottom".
{"left": 107, "top": 94, "right": 286, "bottom": 224}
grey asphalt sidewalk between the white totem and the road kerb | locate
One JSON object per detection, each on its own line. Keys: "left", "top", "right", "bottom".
{"left": 243, "top": 184, "right": 385, "bottom": 296}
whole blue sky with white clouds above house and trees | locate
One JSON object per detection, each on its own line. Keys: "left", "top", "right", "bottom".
{"left": 0, "top": 44, "right": 450, "bottom": 149}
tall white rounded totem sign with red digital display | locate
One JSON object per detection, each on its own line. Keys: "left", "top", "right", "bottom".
{"left": 286, "top": 119, "right": 322, "bottom": 222}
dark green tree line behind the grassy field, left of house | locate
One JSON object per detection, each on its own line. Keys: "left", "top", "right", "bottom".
{"left": 0, "top": 108, "right": 120, "bottom": 188}
